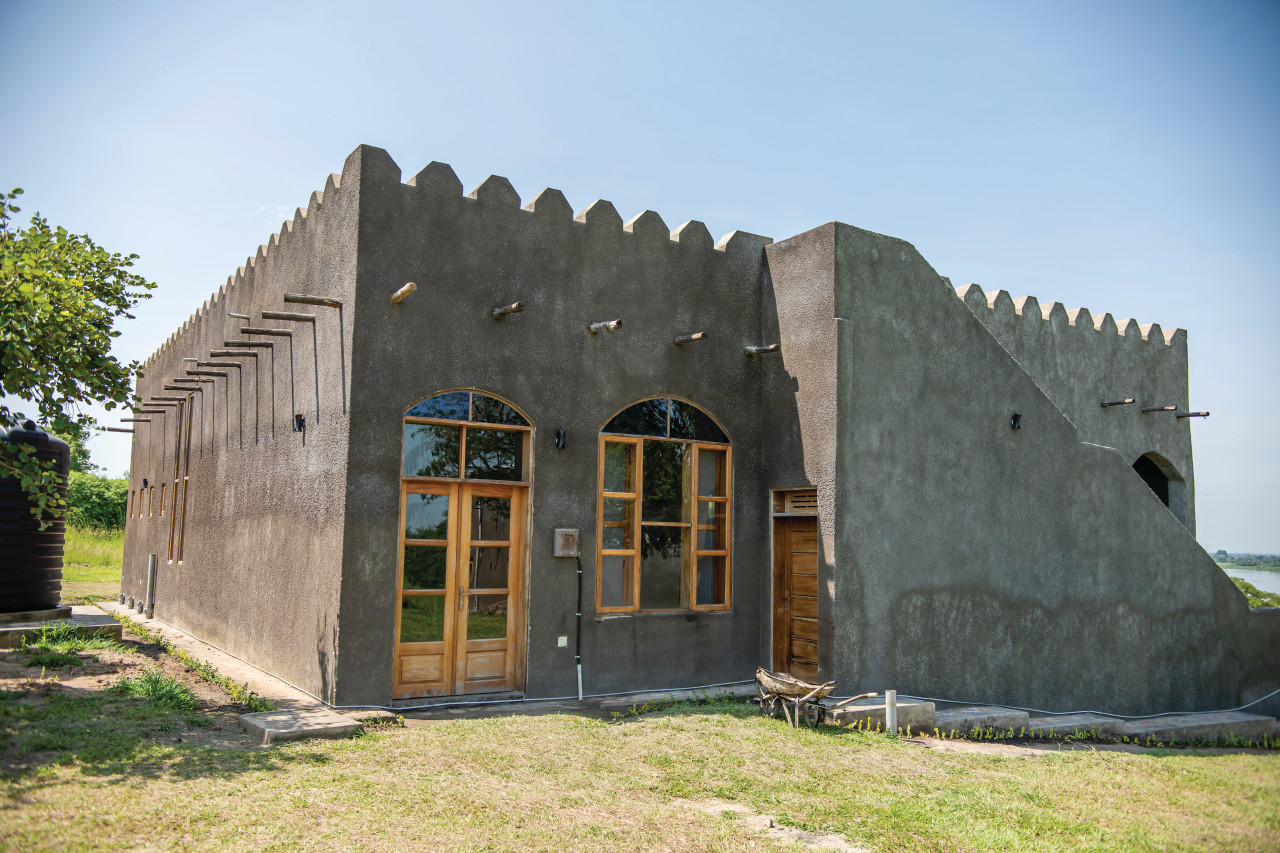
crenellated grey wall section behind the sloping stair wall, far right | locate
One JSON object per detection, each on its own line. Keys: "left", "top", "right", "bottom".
{"left": 957, "top": 284, "right": 1196, "bottom": 527}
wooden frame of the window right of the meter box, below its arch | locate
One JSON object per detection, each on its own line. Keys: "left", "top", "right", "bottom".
{"left": 595, "top": 420, "right": 733, "bottom": 613}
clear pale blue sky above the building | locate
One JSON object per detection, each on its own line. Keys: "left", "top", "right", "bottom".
{"left": 0, "top": 0, "right": 1280, "bottom": 552}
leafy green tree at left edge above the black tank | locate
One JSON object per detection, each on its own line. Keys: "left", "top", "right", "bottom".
{"left": 0, "top": 190, "right": 155, "bottom": 525}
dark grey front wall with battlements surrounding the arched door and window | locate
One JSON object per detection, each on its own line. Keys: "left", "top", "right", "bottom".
{"left": 325, "top": 147, "right": 769, "bottom": 703}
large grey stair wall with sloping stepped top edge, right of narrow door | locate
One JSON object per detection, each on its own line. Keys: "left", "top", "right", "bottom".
{"left": 813, "top": 225, "right": 1280, "bottom": 713}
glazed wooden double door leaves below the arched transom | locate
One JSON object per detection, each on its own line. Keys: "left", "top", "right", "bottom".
{"left": 394, "top": 483, "right": 527, "bottom": 699}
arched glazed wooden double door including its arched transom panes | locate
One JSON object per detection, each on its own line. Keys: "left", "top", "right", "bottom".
{"left": 393, "top": 391, "right": 531, "bottom": 699}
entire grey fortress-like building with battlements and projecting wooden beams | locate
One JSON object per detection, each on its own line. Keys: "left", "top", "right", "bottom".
{"left": 123, "top": 146, "right": 1280, "bottom": 713}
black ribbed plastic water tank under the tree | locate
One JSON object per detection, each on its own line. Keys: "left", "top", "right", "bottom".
{"left": 0, "top": 420, "right": 72, "bottom": 613}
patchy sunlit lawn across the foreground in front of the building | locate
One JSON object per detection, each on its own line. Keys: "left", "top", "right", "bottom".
{"left": 4, "top": 702, "right": 1280, "bottom": 853}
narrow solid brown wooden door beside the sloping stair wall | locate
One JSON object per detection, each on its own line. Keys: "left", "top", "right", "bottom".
{"left": 773, "top": 517, "right": 818, "bottom": 681}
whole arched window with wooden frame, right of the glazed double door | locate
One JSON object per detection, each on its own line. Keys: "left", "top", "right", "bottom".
{"left": 595, "top": 397, "right": 732, "bottom": 612}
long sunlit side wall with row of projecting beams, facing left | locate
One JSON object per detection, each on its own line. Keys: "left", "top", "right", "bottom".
{"left": 122, "top": 163, "right": 358, "bottom": 698}
